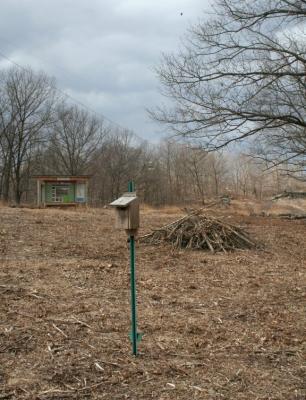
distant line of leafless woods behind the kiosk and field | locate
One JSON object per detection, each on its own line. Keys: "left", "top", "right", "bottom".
{"left": 0, "top": 67, "right": 302, "bottom": 205}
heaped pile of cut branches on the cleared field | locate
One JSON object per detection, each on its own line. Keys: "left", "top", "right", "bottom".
{"left": 139, "top": 210, "right": 257, "bottom": 253}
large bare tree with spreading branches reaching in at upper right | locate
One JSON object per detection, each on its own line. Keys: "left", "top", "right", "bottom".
{"left": 151, "top": 0, "right": 306, "bottom": 177}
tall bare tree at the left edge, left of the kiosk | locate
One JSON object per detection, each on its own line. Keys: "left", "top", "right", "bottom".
{"left": 0, "top": 67, "right": 54, "bottom": 204}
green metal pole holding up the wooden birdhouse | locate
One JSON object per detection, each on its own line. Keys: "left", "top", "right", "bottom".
{"left": 128, "top": 181, "right": 138, "bottom": 356}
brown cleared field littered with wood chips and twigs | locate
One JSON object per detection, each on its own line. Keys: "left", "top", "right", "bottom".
{"left": 0, "top": 207, "right": 306, "bottom": 400}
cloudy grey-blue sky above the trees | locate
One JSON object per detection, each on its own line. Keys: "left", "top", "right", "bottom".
{"left": 0, "top": 0, "right": 211, "bottom": 141}
